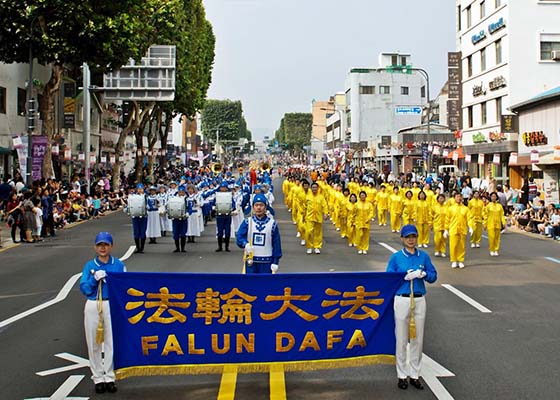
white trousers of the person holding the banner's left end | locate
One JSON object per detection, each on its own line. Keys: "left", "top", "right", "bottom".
{"left": 84, "top": 300, "right": 115, "bottom": 384}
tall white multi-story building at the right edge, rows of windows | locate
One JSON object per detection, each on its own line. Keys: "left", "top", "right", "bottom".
{"left": 456, "top": 0, "right": 560, "bottom": 182}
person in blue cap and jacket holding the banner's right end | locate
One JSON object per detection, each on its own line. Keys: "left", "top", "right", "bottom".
{"left": 387, "top": 225, "right": 437, "bottom": 390}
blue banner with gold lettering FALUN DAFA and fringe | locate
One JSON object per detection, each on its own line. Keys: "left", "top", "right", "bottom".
{"left": 107, "top": 272, "right": 404, "bottom": 379}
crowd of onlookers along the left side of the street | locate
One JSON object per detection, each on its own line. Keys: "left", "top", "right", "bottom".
{"left": 0, "top": 174, "right": 125, "bottom": 243}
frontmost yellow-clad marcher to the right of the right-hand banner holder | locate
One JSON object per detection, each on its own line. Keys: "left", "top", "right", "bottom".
{"left": 443, "top": 193, "right": 469, "bottom": 268}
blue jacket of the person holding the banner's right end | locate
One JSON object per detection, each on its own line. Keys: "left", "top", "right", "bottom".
{"left": 387, "top": 249, "right": 437, "bottom": 296}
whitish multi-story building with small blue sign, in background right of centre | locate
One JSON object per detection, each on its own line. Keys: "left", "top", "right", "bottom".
{"left": 345, "top": 52, "right": 427, "bottom": 169}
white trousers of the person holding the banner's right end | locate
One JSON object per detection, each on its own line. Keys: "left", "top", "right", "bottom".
{"left": 394, "top": 296, "right": 426, "bottom": 379}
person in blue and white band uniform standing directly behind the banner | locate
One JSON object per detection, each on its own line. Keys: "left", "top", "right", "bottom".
{"left": 236, "top": 194, "right": 282, "bottom": 274}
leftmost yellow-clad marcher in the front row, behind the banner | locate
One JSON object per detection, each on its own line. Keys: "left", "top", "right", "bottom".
{"left": 305, "top": 182, "right": 329, "bottom": 254}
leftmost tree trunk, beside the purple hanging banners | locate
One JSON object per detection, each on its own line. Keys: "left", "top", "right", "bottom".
{"left": 40, "top": 62, "right": 64, "bottom": 179}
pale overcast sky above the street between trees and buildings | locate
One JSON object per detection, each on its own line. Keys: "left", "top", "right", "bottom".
{"left": 204, "top": 0, "right": 455, "bottom": 139}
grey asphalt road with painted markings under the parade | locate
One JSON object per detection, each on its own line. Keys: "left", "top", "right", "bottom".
{"left": 0, "top": 180, "right": 560, "bottom": 400}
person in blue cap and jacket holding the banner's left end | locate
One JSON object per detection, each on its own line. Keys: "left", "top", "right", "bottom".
{"left": 80, "top": 231, "right": 125, "bottom": 393}
